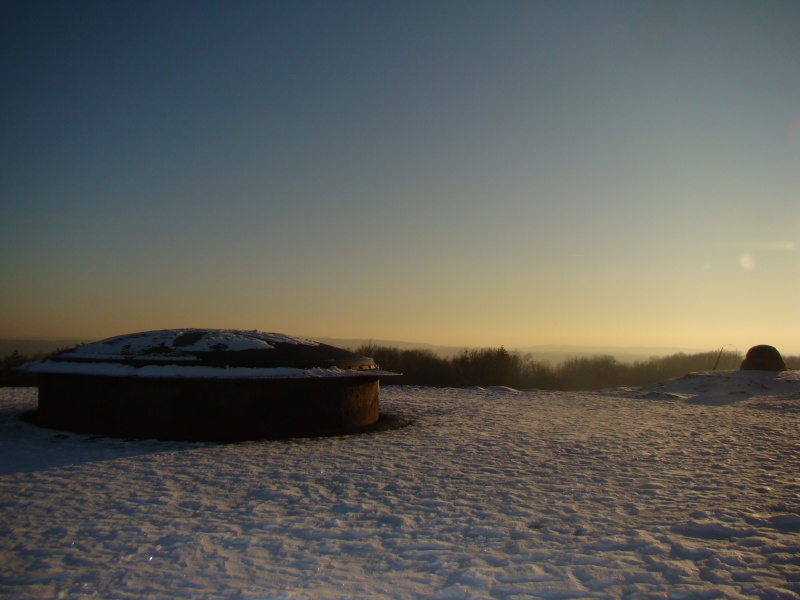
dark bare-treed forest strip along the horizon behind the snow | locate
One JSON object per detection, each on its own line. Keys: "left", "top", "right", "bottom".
{"left": 0, "top": 344, "right": 800, "bottom": 391}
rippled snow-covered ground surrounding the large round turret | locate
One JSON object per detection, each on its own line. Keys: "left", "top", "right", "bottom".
{"left": 0, "top": 371, "right": 800, "bottom": 598}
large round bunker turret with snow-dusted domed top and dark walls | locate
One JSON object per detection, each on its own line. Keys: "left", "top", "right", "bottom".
{"left": 22, "top": 329, "right": 395, "bottom": 441}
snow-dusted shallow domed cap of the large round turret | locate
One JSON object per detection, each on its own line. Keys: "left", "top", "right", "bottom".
{"left": 22, "top": 328, "right": 394, "bottom": 378}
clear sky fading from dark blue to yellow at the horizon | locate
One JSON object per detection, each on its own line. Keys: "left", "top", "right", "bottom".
{"left": 0, "top": 0, "right": 800, "bottom": 353}
